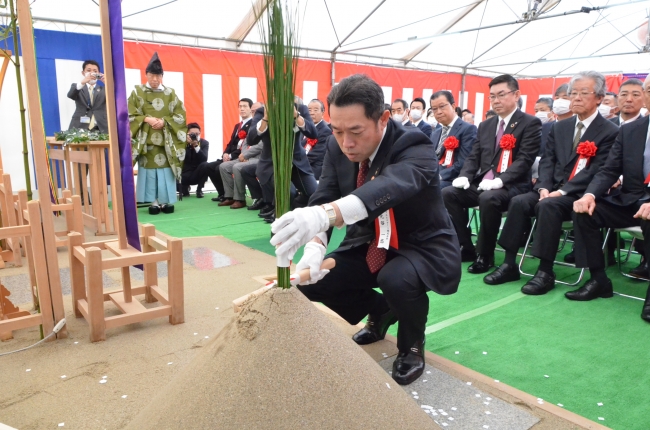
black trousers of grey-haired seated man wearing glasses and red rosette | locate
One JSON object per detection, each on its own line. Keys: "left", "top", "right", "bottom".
{"left": 499, "top": 191, "right": 577, "bottom": 261}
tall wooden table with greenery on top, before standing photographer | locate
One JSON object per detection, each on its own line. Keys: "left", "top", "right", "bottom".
{"left": 47, "top": 137, "right": 115, "bottom": 239}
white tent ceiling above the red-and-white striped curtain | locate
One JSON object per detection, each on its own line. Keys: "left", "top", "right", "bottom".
{"left": 17, "top": 0, "right": 650, "bottom": 76}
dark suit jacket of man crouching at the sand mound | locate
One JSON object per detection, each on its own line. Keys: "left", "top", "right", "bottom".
{"left": 309, "top": 121, "right": 461, "bottom": 294}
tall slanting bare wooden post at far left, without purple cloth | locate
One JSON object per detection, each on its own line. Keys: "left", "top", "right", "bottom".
{"left": 16, "top": 0, "right": 66, "bottom": 338}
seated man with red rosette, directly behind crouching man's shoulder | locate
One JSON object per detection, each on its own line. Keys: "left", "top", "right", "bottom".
{"left": 431, "top": 90, "right": 476, "bottom": 189}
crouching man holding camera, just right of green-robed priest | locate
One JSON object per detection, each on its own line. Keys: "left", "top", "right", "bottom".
{"left": 181, "top": 122, "right": 210, "bottom": 199}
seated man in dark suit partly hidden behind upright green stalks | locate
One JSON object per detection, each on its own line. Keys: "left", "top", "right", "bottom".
{"left": 248, "top": 96, "right": 318, "bottom": 223}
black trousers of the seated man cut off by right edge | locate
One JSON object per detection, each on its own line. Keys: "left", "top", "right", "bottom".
{"left": 573, "top": 200, "right": 650, "bottom": 270}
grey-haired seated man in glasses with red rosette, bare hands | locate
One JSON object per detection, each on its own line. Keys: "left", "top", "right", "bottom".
{"left": 483, "top": 71, "right": 618, "bottom": 295}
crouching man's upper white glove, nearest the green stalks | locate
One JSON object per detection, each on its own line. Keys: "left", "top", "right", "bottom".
{"left": 271, "top": 206, "right": 330, "bottom": 259}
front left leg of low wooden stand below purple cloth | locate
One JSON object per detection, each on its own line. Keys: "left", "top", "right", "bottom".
{"left": 86, "top": 246, "right": 106, "bottom": 342}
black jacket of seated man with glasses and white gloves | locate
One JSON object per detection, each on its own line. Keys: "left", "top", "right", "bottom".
{"left": 459, "top": 109, "right": 542, "bottom": 190}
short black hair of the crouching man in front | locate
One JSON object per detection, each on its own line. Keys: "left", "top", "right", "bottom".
{"left": 327, "top": 74, "right": 385, "bottom": 121}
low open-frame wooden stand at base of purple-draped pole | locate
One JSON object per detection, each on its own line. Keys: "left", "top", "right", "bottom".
{"left": 69, "top": 224, "right": 184, "bottom": 342}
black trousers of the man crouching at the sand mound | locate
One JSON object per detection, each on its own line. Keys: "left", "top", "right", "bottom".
{"left": 298, "top": 245, "right": 429, "bottom": 352}
